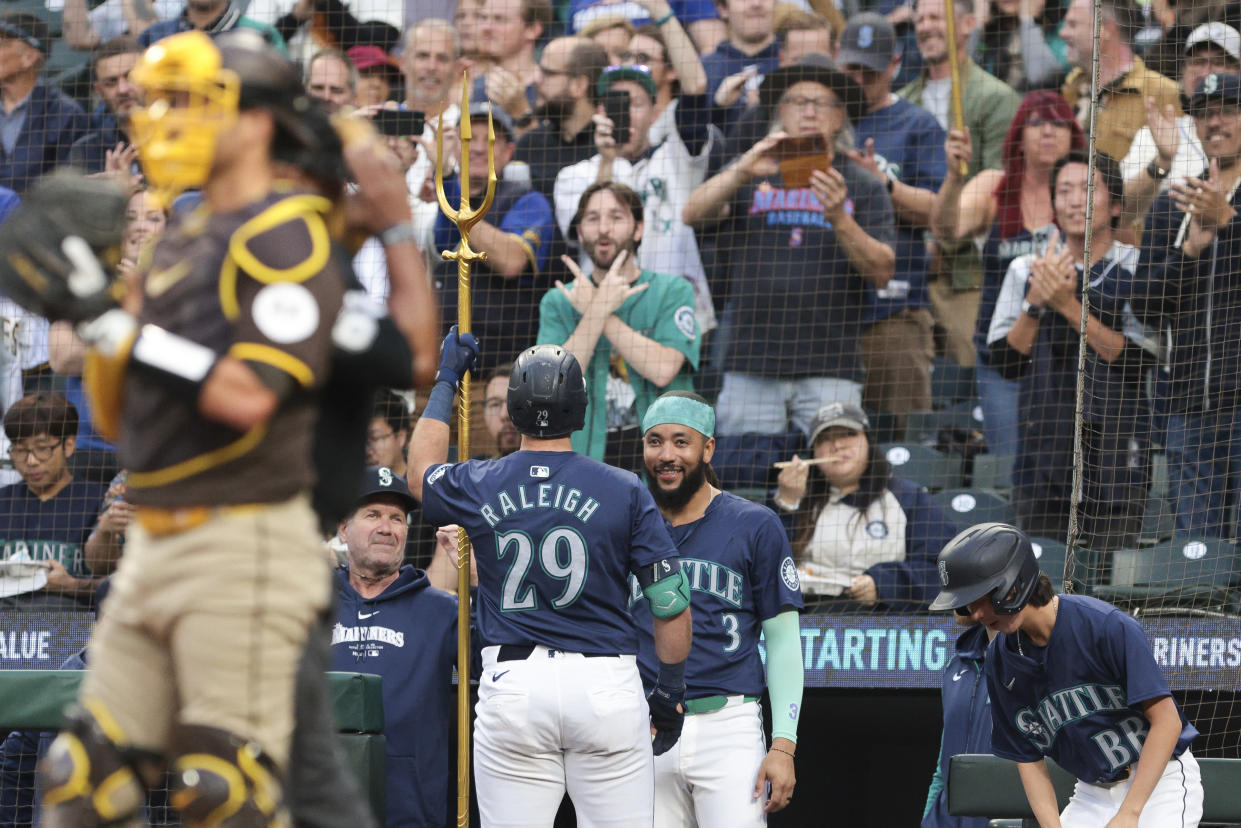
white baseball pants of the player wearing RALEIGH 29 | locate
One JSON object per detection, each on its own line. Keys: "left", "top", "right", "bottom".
{"left": 474, "top": 647, "right": 654, "bottom": 828}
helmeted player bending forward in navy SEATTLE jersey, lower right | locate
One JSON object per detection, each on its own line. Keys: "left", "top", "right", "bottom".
{"left": 931, "top": 524, "right": 1203, "bottom": 828}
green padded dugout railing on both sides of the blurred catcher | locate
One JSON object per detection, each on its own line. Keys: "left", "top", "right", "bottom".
{"left": 0, "top": 670, "right": 386, "bottom": 823}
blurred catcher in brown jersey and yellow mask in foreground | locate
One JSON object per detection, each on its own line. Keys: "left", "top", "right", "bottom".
{"left": 0, "top": 32, "right": 408, "bottom": 826}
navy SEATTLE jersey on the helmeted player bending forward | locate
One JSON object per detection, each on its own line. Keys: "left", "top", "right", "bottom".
{"left": 983, "top": 595, "right": 1198, "bottom": 783}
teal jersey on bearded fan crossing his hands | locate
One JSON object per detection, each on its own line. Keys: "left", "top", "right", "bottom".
{"left": 537, "top": 271, "right": 702, "bottom": 461}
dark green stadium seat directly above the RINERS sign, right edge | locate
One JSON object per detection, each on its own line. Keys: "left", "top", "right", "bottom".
{"left": 1093, "top": 539, "right": 1241, "bottom": 614}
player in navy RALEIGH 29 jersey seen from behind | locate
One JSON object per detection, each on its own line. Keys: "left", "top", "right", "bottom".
{"left": 408, "top": 342, "right": 691, "bottom": 827}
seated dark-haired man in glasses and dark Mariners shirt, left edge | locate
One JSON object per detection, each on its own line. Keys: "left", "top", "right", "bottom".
{"left": 0, "top": 394, "right": 105, "bottom": 610}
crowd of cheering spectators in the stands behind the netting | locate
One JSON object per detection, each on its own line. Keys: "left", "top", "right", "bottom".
{"left": 0, "top": 0, "right": 1241, "bottom": 608}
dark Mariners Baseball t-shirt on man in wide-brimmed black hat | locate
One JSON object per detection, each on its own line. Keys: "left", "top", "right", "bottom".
{"left": 721, "top": 155, "right": 896, "bottom": 382}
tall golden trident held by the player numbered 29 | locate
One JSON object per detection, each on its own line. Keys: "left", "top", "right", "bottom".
{"left": 436, "top": 74, "right": 496, "bottom": 828}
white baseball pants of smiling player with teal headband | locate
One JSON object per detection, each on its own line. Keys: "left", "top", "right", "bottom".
{"left": 655, "top": 696, "right": 767, "bottom": 828}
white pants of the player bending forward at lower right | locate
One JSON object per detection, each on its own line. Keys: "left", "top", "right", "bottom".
{"left": 1060, "top": 750, "right": 1203, "bottom": 828}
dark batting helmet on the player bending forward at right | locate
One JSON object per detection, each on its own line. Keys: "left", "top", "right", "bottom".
{"left": 931, "top": 524, "right": 1041, "bottom": 616}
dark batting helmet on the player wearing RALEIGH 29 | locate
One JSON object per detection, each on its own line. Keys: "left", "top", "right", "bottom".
{"left": 509, "top": 345, "right": 586, "bottom": 439}
